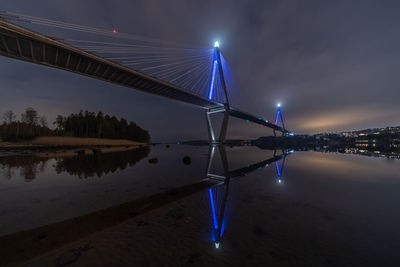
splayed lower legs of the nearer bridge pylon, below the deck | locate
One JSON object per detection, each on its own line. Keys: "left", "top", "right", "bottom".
{"left": 206, "top": 104, "right": 229, "bottom": 144}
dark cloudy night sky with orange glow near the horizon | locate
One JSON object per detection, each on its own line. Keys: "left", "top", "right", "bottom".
{"left": 0, "top": 0, "right": 400, "bottom": 141}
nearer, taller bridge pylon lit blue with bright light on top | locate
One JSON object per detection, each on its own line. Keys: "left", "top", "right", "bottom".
{"left": 206, "top": 42, "right": 230, "bottom": 144}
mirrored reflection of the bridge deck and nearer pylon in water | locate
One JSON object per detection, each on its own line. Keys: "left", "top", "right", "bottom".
{"left": 0, "top": 146, "right": 288, "bottom": 265}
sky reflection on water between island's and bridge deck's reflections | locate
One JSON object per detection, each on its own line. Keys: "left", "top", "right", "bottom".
{"left": 0, "top": 145, "right": 208, "bottom": 235}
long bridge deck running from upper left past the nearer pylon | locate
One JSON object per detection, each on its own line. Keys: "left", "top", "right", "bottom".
{"left": 0, "top": 18, "right": 283, "bottom": 131}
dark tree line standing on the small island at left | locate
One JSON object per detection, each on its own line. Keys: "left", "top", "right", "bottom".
{"left": 0, "top": 107, "right": 150, "bottom": 142}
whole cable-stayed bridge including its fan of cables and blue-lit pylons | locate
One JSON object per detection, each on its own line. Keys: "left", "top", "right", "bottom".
{"left": 0, "top": 12, "right": 289, "bottom": 143}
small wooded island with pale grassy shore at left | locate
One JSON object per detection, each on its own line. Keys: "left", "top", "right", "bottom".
{"left": 0, "top": 107, "right": 150, "bottom": 156}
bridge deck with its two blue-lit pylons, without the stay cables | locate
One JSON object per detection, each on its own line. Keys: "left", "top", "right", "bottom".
{"left": 0, "top": 13, "right": 289, "bottom": 144}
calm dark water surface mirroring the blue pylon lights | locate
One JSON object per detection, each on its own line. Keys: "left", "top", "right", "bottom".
{"left": 0, "top": 145, "right": 400, "bottom": 266}
